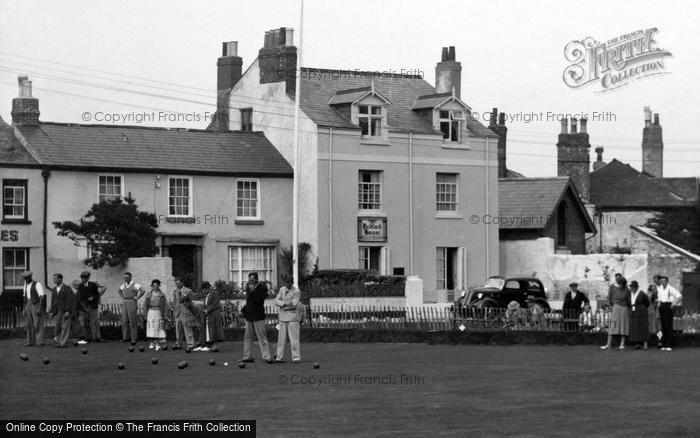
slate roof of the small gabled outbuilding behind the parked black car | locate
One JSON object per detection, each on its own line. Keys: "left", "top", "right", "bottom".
{"left": 498, "top": 177, "right": 595, "bottom": 233}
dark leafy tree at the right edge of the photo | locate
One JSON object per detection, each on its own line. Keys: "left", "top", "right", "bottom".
{"left": 645, "top": 207, "right": 700, "bottom": 254}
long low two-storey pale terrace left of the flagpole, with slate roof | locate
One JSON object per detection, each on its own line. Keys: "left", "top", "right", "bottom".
{"left": 0, "top": 77, "right": 293, "bottom": 298}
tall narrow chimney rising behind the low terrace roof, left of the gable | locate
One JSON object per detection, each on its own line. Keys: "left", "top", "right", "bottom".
{"left": 209, "top": 41, "right": 243, "bottom": 132}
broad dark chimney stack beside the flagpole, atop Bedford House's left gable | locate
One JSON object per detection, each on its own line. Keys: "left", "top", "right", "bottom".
{"left": 258, "top": 27, "right": 297, "bottom": 93}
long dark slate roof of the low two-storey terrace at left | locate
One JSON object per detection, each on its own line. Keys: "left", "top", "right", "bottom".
{"left": 5, "top": 123, "right": 292, "bottom": 177}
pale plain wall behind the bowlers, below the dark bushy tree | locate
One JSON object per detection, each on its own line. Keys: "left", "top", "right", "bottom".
{"left": 48, "top": 257, "right": 175, "bottom": 304}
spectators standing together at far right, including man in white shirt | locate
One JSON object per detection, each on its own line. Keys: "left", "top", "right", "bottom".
{"left": 600, "top": 274, "right": 681, "bottom": 351}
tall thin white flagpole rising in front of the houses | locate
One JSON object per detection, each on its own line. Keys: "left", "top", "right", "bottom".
{"left": 292, "top": 0, "right": 304, "bottom": 288}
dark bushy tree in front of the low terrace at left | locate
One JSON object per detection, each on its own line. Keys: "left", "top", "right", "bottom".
{"left": 53, "top": 196, "right": 159, "bottom": 269}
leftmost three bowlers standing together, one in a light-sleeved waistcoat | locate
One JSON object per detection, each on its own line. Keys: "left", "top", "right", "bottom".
{"left": 22, "top": 271, "right": 106, "bottom": 348}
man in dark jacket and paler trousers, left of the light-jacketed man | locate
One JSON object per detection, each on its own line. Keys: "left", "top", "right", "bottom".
{"left": 238, "top": 272, "right": 274, "bottom": 364}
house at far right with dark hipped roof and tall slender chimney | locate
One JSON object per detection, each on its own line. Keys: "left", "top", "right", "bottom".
{"left": 589, "top": 107, "right": 700, "bottom": 252}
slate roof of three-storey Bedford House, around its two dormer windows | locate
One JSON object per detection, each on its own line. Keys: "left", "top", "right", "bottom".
{"left": 300, "top": 67, "right": 496, "bottom": 137}
